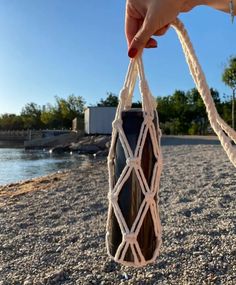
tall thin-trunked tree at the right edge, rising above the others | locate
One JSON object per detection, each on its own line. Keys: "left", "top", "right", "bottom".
{"left": 222, "top": 57, "right": 236, "bottom": 129}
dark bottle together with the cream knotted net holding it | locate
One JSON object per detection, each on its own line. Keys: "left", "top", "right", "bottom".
{"left": 107, "top": 57, "right": 162, "bottom": 267}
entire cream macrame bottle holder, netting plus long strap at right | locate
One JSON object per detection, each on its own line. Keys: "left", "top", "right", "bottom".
{"left": 106, "top": 19, "right": 236, "bottom": 267}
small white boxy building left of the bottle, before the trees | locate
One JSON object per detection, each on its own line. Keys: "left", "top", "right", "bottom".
{"left": 84, "top": 107, "right": 116, "bottom": 134}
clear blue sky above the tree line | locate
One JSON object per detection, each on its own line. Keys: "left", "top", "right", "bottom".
{"left": 0, "top": 0, "right": 236, "bottom": 114}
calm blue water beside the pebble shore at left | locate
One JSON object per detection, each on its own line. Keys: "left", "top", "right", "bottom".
{"left": 0, "top": 148, "right": 91, "bottom": 185}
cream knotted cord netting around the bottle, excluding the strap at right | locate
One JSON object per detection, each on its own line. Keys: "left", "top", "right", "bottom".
{"left": 107, "top": 55, "right": 162, "bottom": 266}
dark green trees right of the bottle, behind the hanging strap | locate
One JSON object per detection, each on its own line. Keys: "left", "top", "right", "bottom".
{"left": 157, "top": 88, "right": 227, "bottom": 135}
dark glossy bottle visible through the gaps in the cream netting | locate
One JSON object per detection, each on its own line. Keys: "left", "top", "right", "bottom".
{"left": 107, "top": 109, "right": 157, "bottom": 262}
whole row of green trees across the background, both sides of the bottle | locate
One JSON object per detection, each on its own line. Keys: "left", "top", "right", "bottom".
{"left": 0, "top": 88, "right": 232, "bottom": 135}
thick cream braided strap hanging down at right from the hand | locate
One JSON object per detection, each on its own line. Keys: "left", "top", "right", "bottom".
{"left": 172, "top": 19, "right": 236, "bottom": 167}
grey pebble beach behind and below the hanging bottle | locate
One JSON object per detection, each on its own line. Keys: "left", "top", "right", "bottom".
{"left": 0, "top": 140, "right": 236, "bottom": 285}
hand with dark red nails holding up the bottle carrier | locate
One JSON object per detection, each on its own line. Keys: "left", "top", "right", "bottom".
{"left": 125, "top": 0, "right": 200, "bottom": 58}
